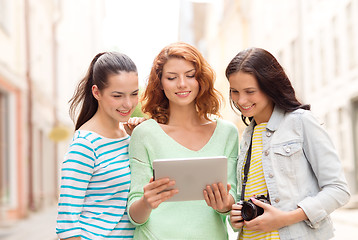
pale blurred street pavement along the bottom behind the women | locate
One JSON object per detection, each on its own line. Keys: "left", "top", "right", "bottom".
{"left": 0, "top": 203, "right": 358, "bottom": 240}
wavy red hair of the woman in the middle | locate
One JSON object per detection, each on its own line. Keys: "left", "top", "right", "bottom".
{"left": 142, "top": 42, "right": 222, "bottom": 124}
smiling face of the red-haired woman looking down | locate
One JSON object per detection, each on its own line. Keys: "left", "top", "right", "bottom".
{"left": 161, "top": 58, "right": 199, "bottom": 106}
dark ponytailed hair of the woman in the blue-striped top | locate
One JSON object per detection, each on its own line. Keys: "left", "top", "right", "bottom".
{"left": 69, "top": 52, "right": 137, "bottom": 130}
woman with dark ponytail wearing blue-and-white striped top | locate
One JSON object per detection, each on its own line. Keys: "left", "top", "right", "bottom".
{"left": 56, "top": 52, "right": 140, "bottom": 239}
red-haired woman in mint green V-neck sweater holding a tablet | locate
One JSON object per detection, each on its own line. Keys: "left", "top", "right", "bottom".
{"left": 128, "top": 42, "right": 238, "bottom": 240}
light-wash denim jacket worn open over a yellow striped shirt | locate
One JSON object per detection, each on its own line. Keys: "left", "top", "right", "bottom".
{"left": 237, "top": 107, "right": 350, "bottom": 240}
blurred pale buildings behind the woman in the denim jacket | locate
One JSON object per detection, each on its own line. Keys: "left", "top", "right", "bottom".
{"left": 182, "top": 0, "right": 358, "bottom": 197}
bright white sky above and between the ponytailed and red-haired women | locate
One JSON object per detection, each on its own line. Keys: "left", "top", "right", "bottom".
{"left": 103, "top": 0, "right": 180, "bottom": 86}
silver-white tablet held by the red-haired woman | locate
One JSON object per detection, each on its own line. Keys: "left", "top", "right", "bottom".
{"left": 153, "top": 156, "right": 227, "bottom": 201}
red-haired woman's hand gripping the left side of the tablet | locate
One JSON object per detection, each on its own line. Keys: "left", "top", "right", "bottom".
{"left": 142, "top": 178, "right": 179, "bottom": 209}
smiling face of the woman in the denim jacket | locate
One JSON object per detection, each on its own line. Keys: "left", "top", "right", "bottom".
{"left": 229, "top": 72, "right": 274, "bottom": 124}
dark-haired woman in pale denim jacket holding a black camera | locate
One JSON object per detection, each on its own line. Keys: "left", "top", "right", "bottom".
{"left": 226, "top": 48, "right": 350, "bottom": 240}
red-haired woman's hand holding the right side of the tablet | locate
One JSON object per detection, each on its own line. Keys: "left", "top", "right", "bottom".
{"left": 204, "top": 182, "right": 234, "bottom": 213}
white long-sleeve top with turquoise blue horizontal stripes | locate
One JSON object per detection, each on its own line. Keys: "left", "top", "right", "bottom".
{"left": 56, "top": 130, "right": 134, "bottom": 239}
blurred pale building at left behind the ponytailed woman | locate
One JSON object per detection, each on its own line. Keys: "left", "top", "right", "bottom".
{"left": 0, "top": 0, "right": 104, "bottom": 227}
